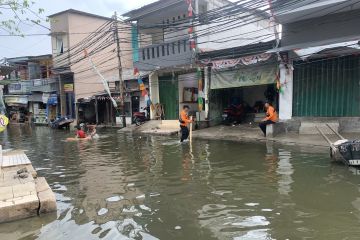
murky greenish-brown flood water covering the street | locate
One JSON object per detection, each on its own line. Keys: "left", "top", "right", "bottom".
{"left": 0, "top": 126, "right": 360, "bottom": 240}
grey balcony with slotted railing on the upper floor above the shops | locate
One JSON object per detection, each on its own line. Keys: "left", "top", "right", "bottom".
{"left": 134, "top": 38, "right": 193, "bottom": 71}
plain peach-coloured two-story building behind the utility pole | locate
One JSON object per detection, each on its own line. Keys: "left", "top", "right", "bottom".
{"left": 49, "top": 9, "right": 133, "bottom": 124}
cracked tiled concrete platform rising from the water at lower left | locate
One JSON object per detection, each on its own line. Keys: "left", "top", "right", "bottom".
{"left": 0, "top": 151, "right": 57, "bottom": 223}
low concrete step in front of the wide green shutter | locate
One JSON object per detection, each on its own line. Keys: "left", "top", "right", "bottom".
{"left": 299, "top": 121, "right": 339, "bottom": 135}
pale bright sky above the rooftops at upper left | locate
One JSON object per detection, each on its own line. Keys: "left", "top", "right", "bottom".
{"left": 0, "top": 0, "right": 156, "bottom": 59}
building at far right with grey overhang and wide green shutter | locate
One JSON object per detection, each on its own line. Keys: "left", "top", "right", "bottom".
{"left": 272, "top": 0, "right": 360, "bottom": 129}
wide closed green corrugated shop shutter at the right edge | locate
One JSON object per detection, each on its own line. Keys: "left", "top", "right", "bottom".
{"left": 293, "top": 56, "right": 360, "bottom": 117}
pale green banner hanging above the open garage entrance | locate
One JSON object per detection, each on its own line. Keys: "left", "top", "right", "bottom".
{"left": 211, "top": 65, "right": 278, "bottom": 89}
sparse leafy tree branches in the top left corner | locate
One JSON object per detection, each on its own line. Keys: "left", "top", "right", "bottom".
{"left": 0, "top": 0, "right": 46, "bottom": 35}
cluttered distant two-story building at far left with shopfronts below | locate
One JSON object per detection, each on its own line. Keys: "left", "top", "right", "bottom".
{"left": 4, "top": 55, "right": 58, "bottom": 124}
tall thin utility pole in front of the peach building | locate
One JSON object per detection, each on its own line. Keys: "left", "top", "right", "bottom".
{"left": 114, "top": 12, "right": 126, "bottom": 127}
